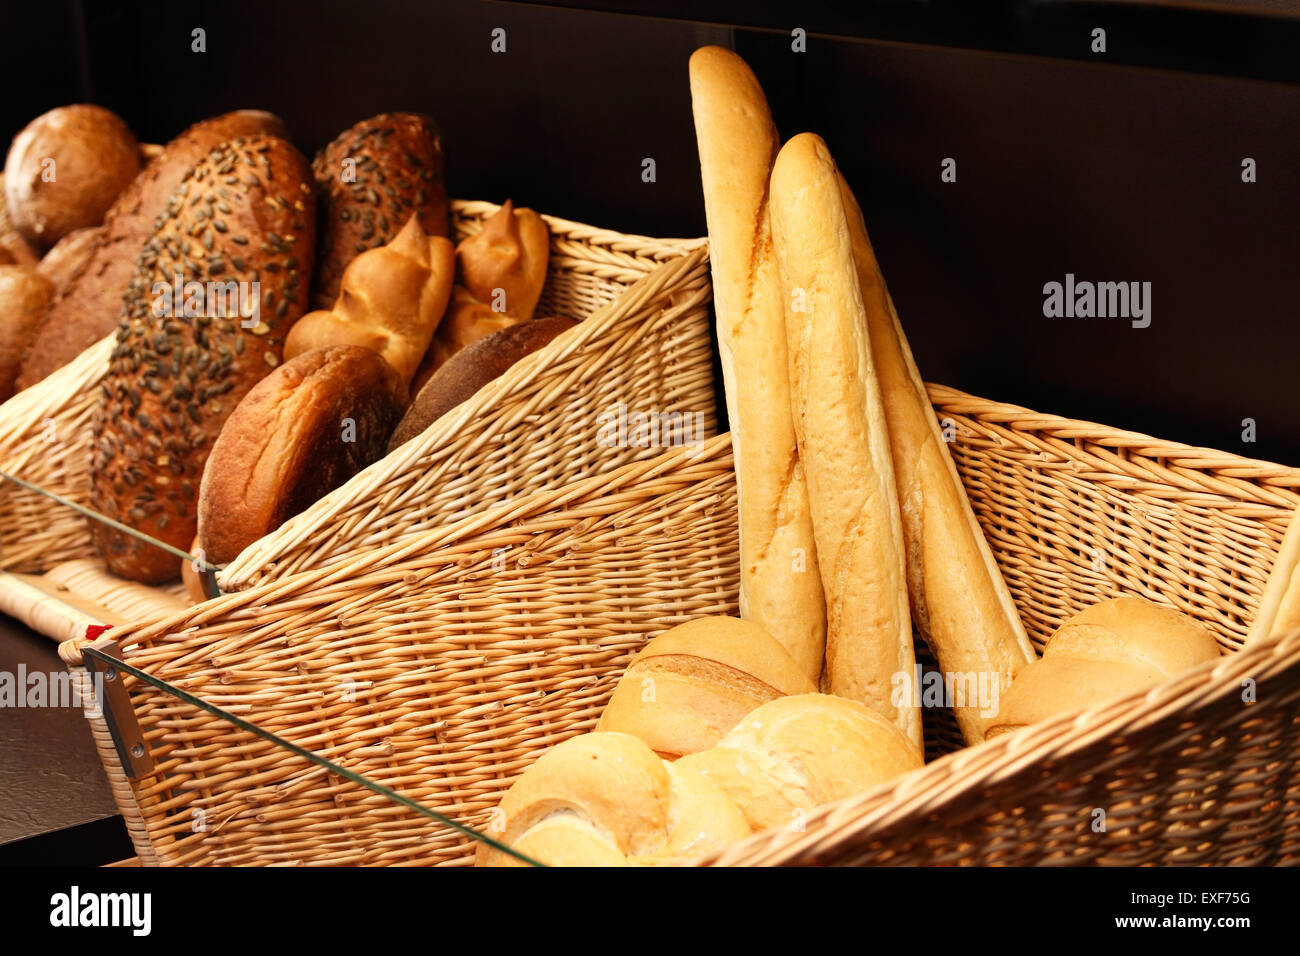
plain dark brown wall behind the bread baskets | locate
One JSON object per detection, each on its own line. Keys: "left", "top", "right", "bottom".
{"left": 0, "top": 0, "right": 1300, "bottom": 464}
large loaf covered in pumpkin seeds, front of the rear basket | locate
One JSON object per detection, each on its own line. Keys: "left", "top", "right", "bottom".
{"left": 91, "top": 137, "right": 316, "bottom": 584}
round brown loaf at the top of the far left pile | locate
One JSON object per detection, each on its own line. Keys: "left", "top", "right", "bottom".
{"left": 4, "top": 103, "right": 140, "bottom": 248}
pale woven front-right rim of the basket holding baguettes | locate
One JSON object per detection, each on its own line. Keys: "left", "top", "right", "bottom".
{"left": 693, "top": 628, "right": 1300, "bottom": 866}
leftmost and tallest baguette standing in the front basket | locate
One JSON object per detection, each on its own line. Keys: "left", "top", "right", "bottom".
{"left": 690, "top": 47, "right": 826, "bottom": 680}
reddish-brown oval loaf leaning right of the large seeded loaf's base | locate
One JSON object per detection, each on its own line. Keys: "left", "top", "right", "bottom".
{"left": 199, "top": 345, "right": 407, "bottom": 564}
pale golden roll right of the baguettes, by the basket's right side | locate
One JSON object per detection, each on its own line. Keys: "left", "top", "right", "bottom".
{"left": 985, "top": 597, "right": 1219, "bottom": 739}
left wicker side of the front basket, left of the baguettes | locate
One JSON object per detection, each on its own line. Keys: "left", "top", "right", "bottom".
{"left": 61, "top": 436, "right": 740, "bottom": 865}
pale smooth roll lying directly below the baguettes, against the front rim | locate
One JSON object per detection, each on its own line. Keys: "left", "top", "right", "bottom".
{"left": 677, "top": 693, "right": 924, "bottom": 831}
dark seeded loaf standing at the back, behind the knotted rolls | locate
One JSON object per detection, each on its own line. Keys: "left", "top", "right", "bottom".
{"left": 312, "top": 113, "right": 449, "bottom": 310}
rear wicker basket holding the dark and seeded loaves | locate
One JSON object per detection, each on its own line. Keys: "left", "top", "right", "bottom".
{"left": 0, "top": 202, "right": 716, "bottom": 640}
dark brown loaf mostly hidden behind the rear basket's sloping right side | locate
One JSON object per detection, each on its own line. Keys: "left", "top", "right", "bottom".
{"left": 389, "top": 319, "right": 577, "bottom": 451}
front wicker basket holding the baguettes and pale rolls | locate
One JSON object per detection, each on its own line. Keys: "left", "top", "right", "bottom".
{"left": 61, "top": 386, "right": 1300, "bottom": 864}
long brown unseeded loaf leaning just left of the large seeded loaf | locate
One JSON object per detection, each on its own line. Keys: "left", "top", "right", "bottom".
{"left": 17, "top": 109, "right": 285, "bottom": 390}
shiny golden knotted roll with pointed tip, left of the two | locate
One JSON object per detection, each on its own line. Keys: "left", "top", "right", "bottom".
{"left": 285, "top": 215, "right": 455, "bottom": 389}
